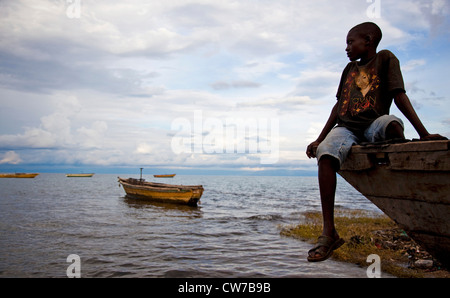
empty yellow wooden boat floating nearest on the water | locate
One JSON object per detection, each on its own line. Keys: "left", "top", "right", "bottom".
{"left": 118, "top": 177, "right": 203, "bottom": 206}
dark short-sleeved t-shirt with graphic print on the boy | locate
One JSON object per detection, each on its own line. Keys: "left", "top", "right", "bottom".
{"left": 336, "top": 50, "right": 405, "bottom": 135}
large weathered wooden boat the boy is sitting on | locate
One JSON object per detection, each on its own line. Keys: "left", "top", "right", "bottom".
{"left": 339, "top": 141, "right": 450, "bottom": 267}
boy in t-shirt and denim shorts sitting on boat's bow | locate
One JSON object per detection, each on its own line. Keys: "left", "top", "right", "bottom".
{"left": 306, "top": 22, "right": 446, "bottom": 262}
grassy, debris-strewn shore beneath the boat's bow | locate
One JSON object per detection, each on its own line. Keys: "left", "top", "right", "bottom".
{"left": 280, "top": 209, "right": 450, "bottom": 278}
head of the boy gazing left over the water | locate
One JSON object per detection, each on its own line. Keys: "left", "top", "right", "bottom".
{"left": 345, "top": 22, "right": 382, "bottom": 61}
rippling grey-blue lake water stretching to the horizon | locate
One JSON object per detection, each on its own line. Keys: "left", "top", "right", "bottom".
{"left": 0, "top": 174, "right": 380, "bottom": 278}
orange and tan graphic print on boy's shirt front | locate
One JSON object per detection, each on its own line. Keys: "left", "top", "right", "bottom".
{"left": 340, "top": 68, "right": 380, "bottom": 116}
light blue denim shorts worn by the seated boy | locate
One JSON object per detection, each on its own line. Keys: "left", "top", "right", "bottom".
{"left": 316, "top": 115, "right": 404, "bottom": 165}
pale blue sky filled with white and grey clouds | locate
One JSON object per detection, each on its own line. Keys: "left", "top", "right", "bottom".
{"left": 0, "top": 0, "right": 450, "bottom": 172}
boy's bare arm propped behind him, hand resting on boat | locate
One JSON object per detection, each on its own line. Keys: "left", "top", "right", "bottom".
{"left": 394, "top": 92, "right": 447, "bottom": 140}
